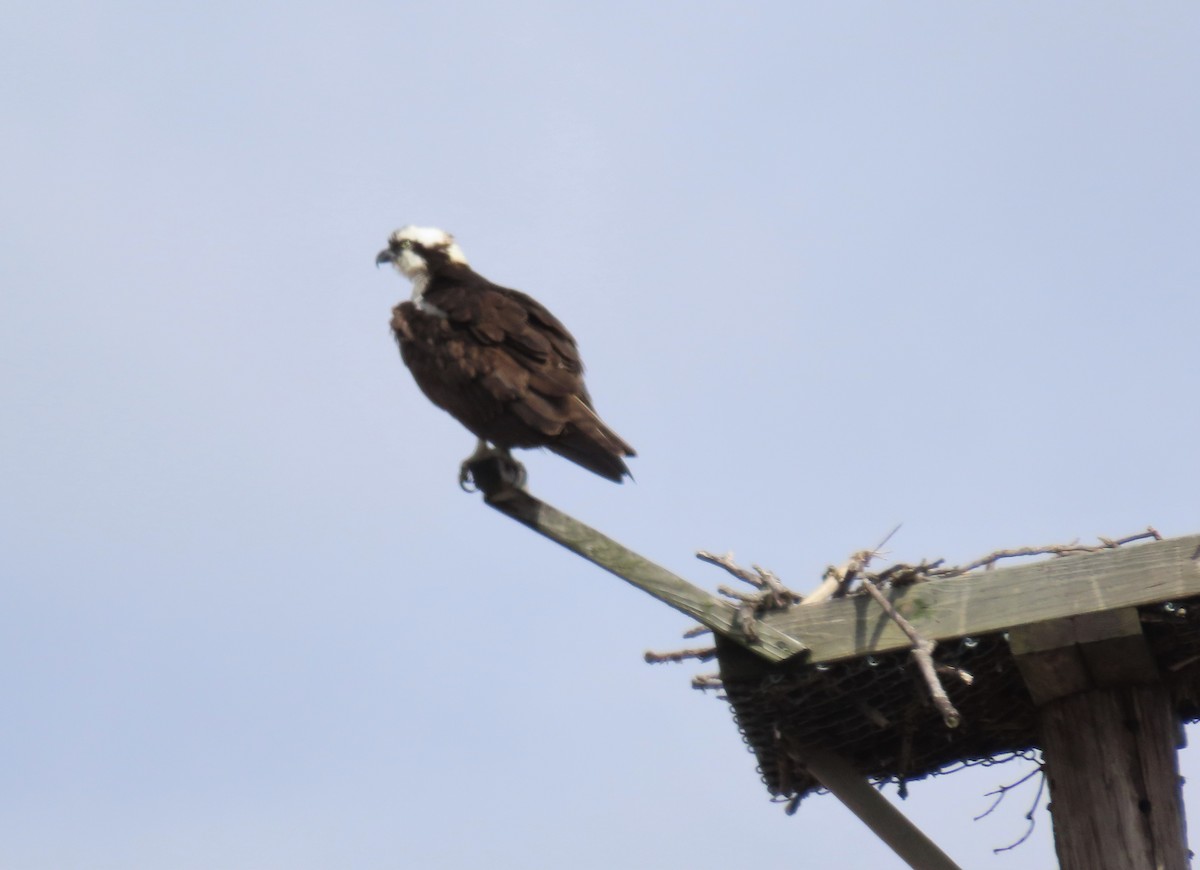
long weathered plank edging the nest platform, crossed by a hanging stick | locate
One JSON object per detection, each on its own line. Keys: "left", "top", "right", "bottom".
{"left": 762, "top": 535, "right": 1200, "bottom": 662}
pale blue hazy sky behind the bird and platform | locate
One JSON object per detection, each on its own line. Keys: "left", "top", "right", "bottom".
{"left": 0, "top": 2, "right": 1200, "bottom": 870}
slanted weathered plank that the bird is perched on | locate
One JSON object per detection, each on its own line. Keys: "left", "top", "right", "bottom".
{"left": 485, "top": 488, "right": 806, "bottom": 661}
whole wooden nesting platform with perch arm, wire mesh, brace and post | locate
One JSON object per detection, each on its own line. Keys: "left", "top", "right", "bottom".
{"left": 467, "top": 460, "right": 1200, "bottom": 870}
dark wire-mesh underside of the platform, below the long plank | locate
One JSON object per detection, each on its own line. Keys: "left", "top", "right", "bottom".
{"left": 718, "top": 592, "right": 1200, "bottom": 799}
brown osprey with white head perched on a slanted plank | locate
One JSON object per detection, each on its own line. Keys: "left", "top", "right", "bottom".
{"left": 376, "top": 227, "right": 634, "bottom": 484}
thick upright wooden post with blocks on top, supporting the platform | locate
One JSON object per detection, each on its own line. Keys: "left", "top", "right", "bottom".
{"left": 1010, "top": 608, "right": 1189, "bottom": 870}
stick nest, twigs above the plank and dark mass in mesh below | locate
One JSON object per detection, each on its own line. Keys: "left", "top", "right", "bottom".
{"left": 646, "top": 528, "right": 1200, "bottom": 811}
